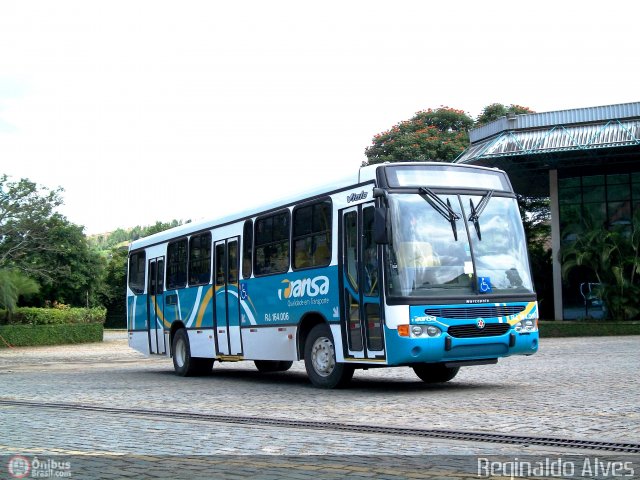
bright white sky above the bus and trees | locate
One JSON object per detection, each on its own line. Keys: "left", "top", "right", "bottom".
{"left": 0, "top": 0, "right": 640, "bottom": 234}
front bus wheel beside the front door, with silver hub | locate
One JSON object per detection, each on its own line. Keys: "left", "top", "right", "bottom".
{"left": 304, "top": 323, "right": 354, "bottom": 388}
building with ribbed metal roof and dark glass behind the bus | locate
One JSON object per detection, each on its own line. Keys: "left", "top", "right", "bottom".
{"left": 456, "top": 102, "right": 640, "bottom": 320}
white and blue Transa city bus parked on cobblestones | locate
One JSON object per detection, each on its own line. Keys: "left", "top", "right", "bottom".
{"left": 127, "top": 163, "right": 538, "bottom": 388}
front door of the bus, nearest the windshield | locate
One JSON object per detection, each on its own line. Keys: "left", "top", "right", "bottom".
{"left": 340, "top": 203, "right": 385, "bottom": 359}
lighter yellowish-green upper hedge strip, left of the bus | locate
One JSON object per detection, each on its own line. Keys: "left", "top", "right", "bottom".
{"left": 0, "top": 307, "right": 107, "bottom": 325}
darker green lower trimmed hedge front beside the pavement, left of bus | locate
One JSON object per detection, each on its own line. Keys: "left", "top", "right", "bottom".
{"left": 0, "top": 323, "right": 104, "bottom": 348}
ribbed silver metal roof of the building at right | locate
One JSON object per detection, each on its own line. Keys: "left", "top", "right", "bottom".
{"left": 456, "top": 102, "right": 640, "bottom": 195}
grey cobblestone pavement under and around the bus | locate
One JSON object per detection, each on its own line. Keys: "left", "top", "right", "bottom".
{"left": 0, "top": 333, "right": 640, "bottom": 478}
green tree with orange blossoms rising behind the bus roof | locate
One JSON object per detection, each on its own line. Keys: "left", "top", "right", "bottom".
{"left": 365, "top": 107, "right": 473, "bottom": 165}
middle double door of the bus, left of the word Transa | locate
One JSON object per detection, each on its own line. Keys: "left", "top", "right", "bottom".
{"left": 214, "top": 237, "right": 242, "bottom": 355}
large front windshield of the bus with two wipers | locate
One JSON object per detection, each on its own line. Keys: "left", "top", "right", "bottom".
{"left": 386, "top": 193, "right": 533, "bottom": 297}
